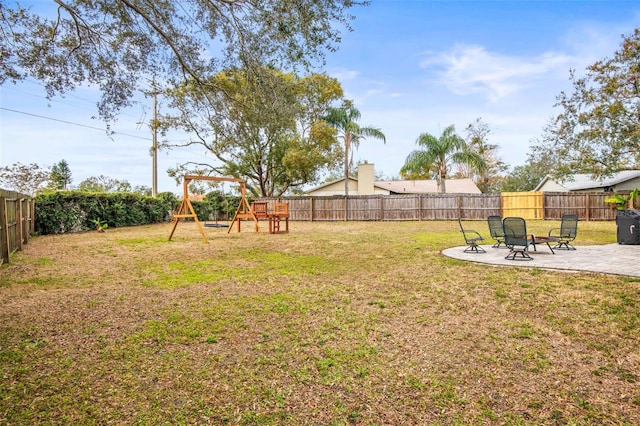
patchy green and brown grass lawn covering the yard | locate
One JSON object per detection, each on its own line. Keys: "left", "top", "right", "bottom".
{"left": 0, "top": 221, "right": 640, "bottom": 425}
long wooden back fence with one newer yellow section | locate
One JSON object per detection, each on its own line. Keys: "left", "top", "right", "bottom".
{"left": 261, "top": 192, "right": 616, "bottom": 221}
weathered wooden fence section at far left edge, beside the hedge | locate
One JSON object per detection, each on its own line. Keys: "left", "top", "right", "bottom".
{"left": 0, "top": 189, "right": 35, "bottom": 264}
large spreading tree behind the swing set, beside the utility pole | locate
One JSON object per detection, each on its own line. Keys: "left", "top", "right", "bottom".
{"left": 161, "top": 67, "right": 342, "bottom": 196}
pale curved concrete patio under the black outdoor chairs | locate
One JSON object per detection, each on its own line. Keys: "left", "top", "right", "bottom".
{"left": 442, "top": 244, "right": 640, "bottom": 277}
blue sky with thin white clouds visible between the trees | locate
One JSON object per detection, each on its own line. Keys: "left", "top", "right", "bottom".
{"left": 0, "top": 0, "right": 640, "bottom": 192}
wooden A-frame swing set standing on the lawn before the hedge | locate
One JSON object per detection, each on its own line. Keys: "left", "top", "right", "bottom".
{"left": 169, "top": 175, "right": 260, "bottom": 243}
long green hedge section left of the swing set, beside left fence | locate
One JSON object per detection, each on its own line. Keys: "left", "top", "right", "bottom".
{"left": 35, "top": 191, "right": 179, "bottom": 234}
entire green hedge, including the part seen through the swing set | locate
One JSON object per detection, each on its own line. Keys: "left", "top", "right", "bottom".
{"left": 35, "top": 191, "right": 246, "bottom": 235}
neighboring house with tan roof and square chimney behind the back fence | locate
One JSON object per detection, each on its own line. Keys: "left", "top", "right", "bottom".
{"left": 305, "top": 163, "right": 482, "bottom": 197}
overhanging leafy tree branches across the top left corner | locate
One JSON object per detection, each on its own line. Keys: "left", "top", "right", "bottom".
{"left": 0, "top": 0, "right": 367, "bottom": 119}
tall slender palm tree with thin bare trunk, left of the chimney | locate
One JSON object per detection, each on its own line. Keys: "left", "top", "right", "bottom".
{"left": 323, "top": 100, "right": 387, "bottom": 195}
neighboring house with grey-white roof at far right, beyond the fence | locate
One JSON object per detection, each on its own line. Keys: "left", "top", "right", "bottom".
{"left": 534, "top": 170, "right": 640, "bottom": 192}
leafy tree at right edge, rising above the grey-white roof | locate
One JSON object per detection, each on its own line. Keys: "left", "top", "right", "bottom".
{"left": 532, "top": 29, "right": 640, "bottom": 178}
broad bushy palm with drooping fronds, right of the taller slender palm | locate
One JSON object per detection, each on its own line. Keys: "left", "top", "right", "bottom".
{"left": 400, "top": 124, "right": 485, "bottom": 194}
